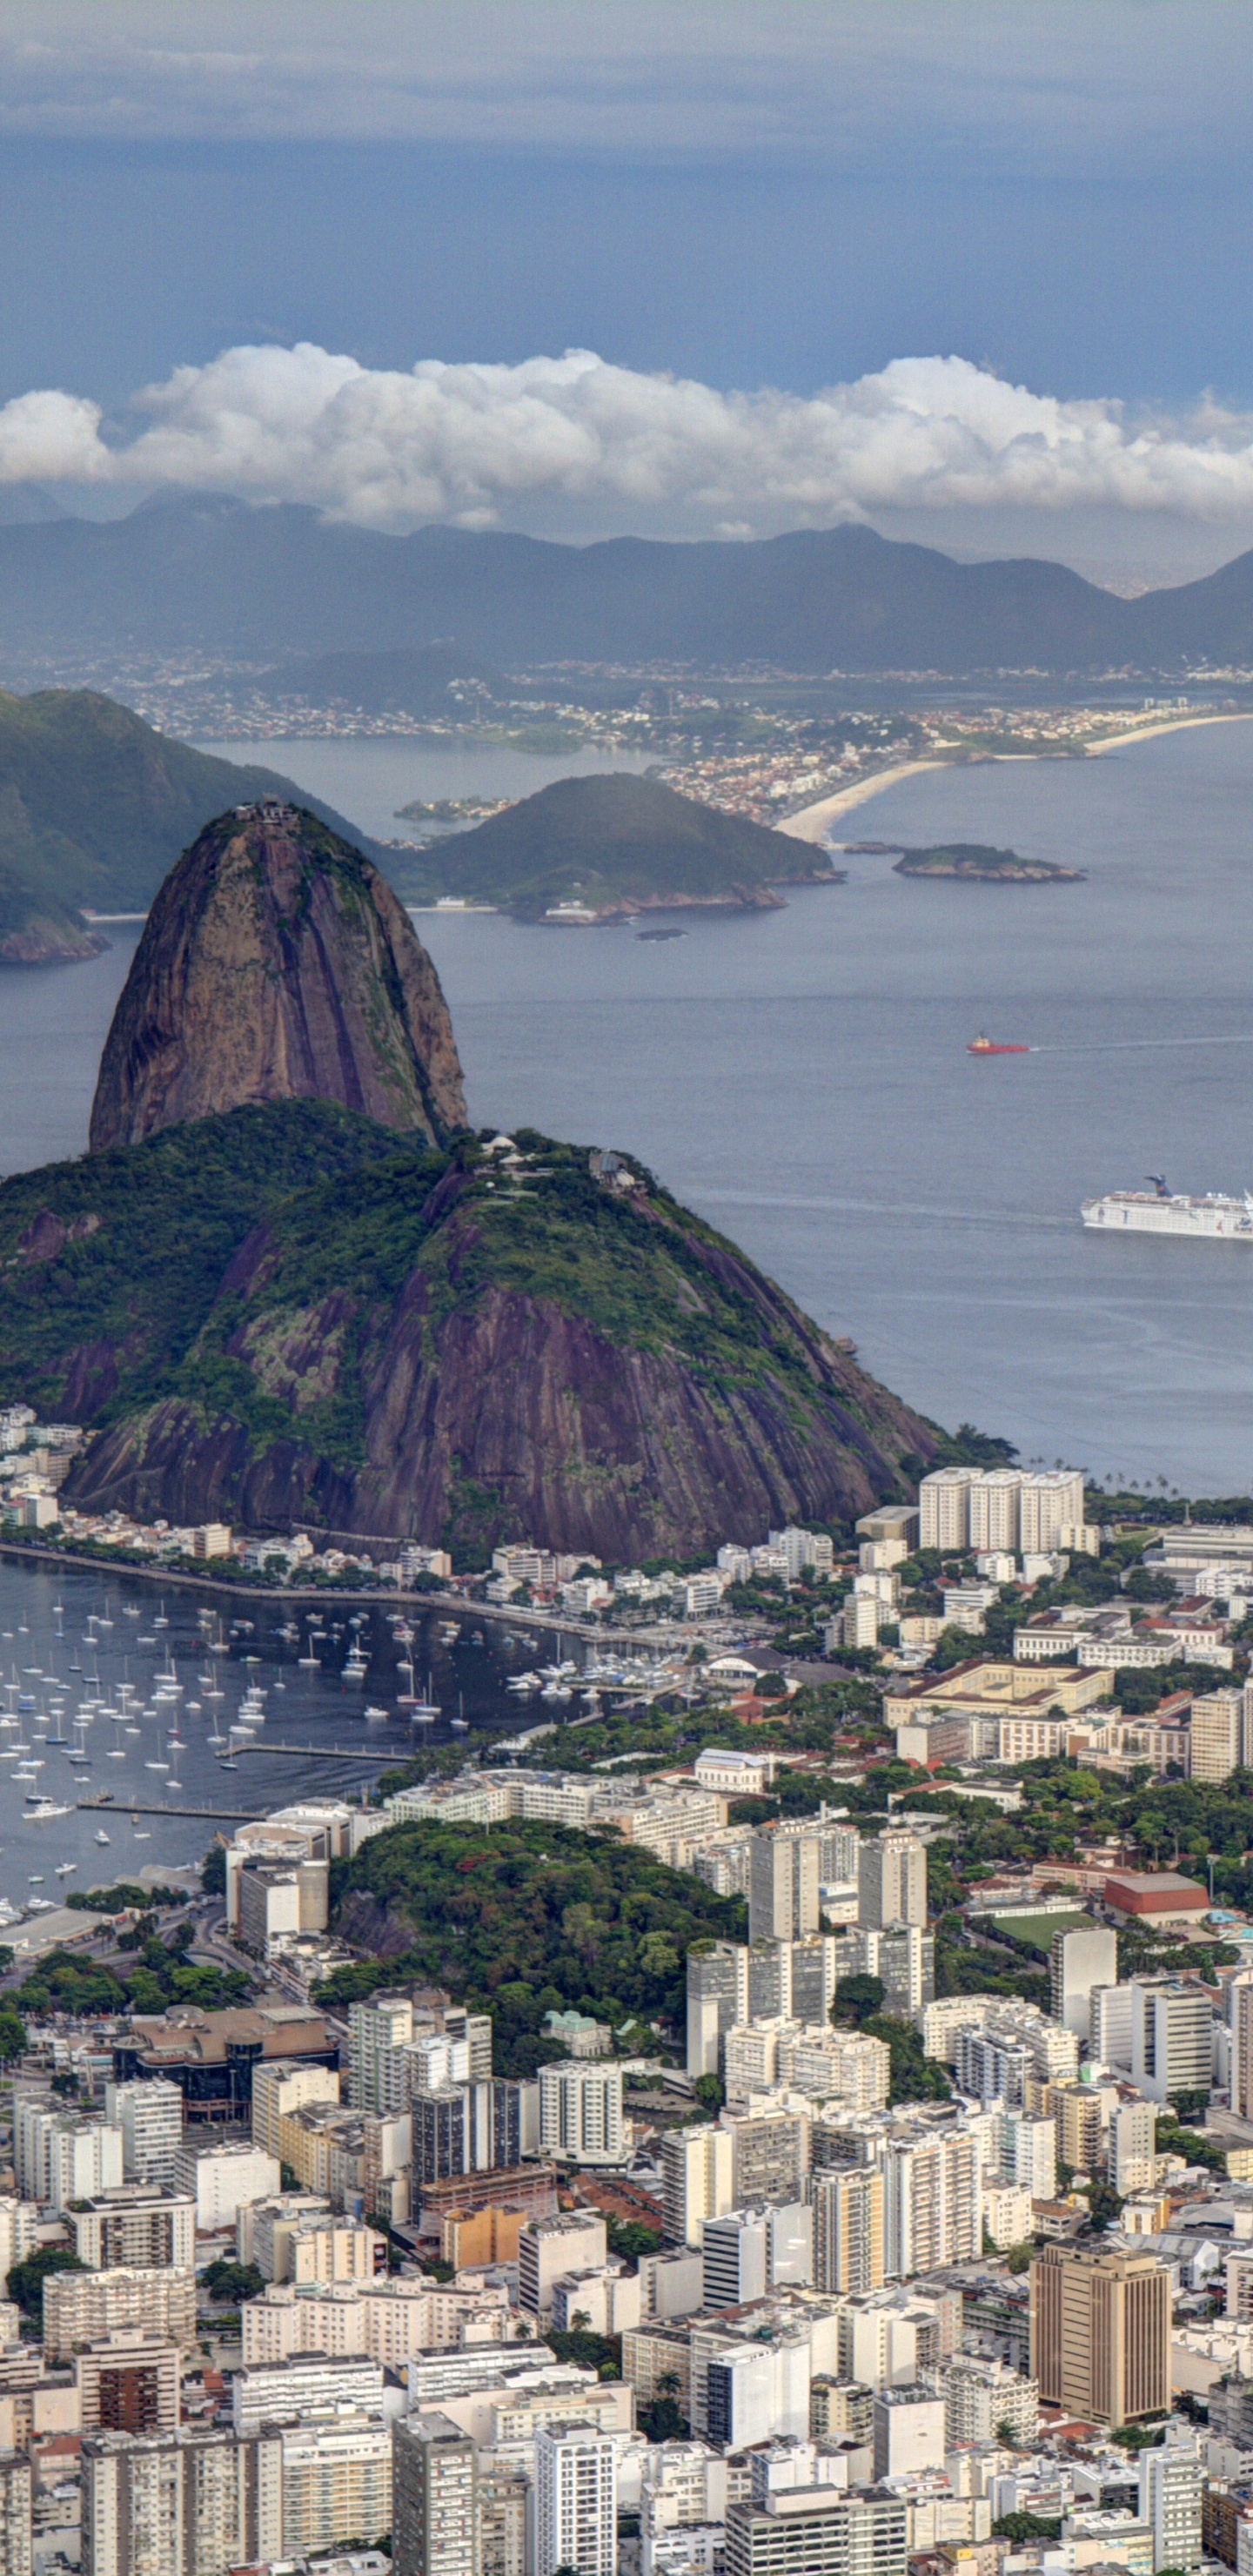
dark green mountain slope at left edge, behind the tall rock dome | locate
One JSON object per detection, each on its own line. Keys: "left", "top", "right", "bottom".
{"left": 0, "top": 688, "right": 389, "bottom": 963}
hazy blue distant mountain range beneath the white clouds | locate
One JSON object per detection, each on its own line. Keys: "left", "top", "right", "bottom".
{"left": 0, "top": 497, "right": 1253, "bottom": 675}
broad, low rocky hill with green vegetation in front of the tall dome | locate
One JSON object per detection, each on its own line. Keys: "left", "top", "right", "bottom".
{"left": 0, "top": 1100, "right": 936, "bottom": 1561}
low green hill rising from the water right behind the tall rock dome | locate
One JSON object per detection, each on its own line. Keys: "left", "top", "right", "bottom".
{"left": 405, "top": 770, "right": 838, "bottom": 922}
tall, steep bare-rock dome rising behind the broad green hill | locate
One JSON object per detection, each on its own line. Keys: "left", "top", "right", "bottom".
{"left": 90, "top": 799, "right": 464, "bottom": 1154}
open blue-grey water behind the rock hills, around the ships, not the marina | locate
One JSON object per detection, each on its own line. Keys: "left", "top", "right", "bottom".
{"left": 0, "top": 721, "right": 1253, "bottom": 1494}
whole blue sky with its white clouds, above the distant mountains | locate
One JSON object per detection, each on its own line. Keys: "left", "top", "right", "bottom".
{"left": 0, "top": 0, "right": 1253, "bottom": 572}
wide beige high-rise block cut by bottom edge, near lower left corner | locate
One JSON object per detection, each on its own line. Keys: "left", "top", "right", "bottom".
{"left": 83, "top": 2432, "right": 284, "bottom": 2576}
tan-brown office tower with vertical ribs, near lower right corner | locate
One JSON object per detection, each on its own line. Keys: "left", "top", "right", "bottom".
{"left": 1029, "top": 2244, "right": 1170, "bottom": 2426}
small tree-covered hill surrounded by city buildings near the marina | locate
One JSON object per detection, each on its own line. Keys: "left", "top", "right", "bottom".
{"left": 319, "top": 1821, "right": 745, "bottom": 2074}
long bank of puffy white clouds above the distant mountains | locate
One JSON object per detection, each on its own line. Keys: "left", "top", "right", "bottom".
{"left": 12, "top": 343, "right": 1253, "bottom": 536}
